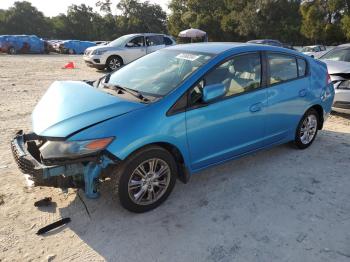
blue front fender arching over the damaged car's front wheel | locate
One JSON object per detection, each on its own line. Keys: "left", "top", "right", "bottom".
{"left": 69, "top": 105, "right": 190, "bottom": 167}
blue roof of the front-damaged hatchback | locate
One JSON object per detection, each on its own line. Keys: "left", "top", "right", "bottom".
{"left": 166, "top": 42, "right": 302, "bottom": 56}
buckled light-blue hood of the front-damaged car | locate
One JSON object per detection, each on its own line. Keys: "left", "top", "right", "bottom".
{"left": 32, "top": 81, "right": 145, "bottom": 137}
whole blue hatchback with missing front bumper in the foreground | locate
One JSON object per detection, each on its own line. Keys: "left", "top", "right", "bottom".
{"left": 11, "top": 43, "right": 334, "bottom": 212}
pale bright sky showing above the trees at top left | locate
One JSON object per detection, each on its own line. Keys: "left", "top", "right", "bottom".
{"left": 0, "top": 0, "right": 170, "bottom": 16}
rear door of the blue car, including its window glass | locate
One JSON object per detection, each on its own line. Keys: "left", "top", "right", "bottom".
{"left": 266, "top": 52, "right": 310, "bottom": 144}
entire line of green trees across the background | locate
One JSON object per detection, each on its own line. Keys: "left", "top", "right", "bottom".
{"left": 0, "top": 0, "right": 350, "bottom": 45}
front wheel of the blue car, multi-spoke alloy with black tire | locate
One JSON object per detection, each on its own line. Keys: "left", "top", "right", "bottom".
{"left": 118, "top": 146, "right": 177, "bottom": 213}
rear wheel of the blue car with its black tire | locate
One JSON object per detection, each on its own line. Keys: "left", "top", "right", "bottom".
{"left": 294, "top": 108, "right": 320, "bottom": 149}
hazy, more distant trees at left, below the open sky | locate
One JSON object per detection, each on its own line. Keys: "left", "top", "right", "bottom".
{"left": 0, "top": 0, "right": 167, "bottom": 40}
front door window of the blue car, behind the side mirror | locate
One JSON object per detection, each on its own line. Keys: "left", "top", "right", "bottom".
{"left": 190, "top": 53, "right": 261, "bottom": 104}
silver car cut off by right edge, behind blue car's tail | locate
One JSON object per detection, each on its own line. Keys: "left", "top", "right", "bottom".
{"left": 320, "top": 44, "right": 350, "bottom": 114}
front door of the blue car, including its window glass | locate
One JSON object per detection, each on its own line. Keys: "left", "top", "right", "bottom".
{"left": 186, "top": 53, "right": 267, "bottom": 170}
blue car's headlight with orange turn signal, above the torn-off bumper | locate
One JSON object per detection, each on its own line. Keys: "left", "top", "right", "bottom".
{"left": 40, "top": 137, "right": 114, "bottom": 159}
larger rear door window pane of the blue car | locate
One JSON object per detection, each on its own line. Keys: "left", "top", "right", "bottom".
{"left": 267, "top": 54, "right": 298, "bottom": 84}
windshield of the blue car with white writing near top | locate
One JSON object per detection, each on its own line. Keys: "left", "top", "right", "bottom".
{"left": 109, "top": 49, "right": 213, "bottom": 97}
